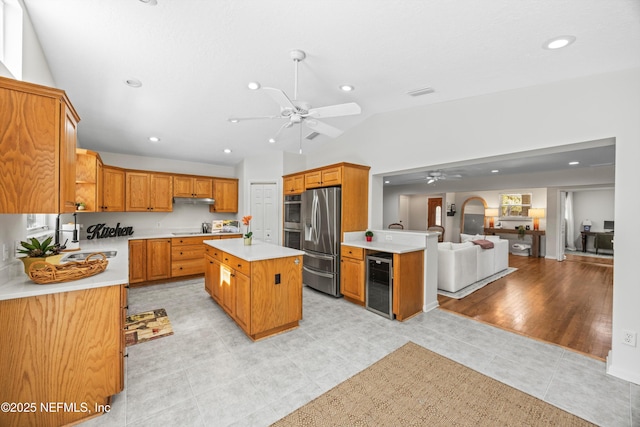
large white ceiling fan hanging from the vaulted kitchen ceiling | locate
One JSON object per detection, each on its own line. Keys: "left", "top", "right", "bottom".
{"left": 229, "top": 49, "right": 362, "bottom": 153}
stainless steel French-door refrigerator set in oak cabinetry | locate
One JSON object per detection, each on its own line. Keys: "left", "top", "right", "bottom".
{"left": 302, "top": 187, "right": 342, "bottom": 297}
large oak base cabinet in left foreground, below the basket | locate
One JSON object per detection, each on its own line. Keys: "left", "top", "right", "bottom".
{"left": 0, "top": 285, "right": 126, "bottom": 427}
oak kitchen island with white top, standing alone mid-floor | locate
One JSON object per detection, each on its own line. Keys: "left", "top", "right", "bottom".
{"left": 204, "top": 239, "right": 304, "bottom": 341}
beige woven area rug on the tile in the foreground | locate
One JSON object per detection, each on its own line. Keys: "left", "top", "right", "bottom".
{"left": 273, "top": 342, "right": 594, "bottom": 427}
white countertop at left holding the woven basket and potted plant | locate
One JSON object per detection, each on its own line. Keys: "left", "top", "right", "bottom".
{"left": 0, "top": 237, "right": 129, "bottom": 300}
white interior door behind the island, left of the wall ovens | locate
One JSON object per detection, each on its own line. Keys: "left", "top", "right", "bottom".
{"left": 251, "top": 183, "right": 280, "bottom": 245}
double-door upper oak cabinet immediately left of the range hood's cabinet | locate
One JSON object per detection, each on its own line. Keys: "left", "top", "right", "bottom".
{"left": 125, "top": 171, "right": 173, "bottom": 212}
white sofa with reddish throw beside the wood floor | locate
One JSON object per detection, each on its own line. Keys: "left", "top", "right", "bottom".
{"left": 438, "top": 235, "right": 509, "bottom": 292}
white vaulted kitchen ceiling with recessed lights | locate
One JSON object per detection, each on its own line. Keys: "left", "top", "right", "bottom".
{"left": 24, "top": 0, "right": 640, "bottom": 172}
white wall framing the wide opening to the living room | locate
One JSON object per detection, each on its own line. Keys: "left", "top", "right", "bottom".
{"left": 308, "top": 69, "right": 640, "bottom": 383}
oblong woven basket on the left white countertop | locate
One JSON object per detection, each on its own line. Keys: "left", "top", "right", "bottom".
{"left": 27, "top": 252, "right": 109, "bottom": 285}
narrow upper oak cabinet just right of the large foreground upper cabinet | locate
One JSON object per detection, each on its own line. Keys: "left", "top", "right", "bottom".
{"left": 76, "top": 148, "right": 103, "bottom": 212}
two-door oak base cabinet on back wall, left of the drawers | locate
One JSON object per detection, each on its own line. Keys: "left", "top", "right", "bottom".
{"left": 129, "top": 239, "right": 171, "bottom": 284}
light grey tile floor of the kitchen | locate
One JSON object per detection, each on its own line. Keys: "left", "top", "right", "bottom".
{"left": 82, "top": 279, "right": 640, "bottom": 427}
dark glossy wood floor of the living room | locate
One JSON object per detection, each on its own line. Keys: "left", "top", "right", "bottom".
{"left": 438, "top": 255, "right": 613, "bottom": 360}
